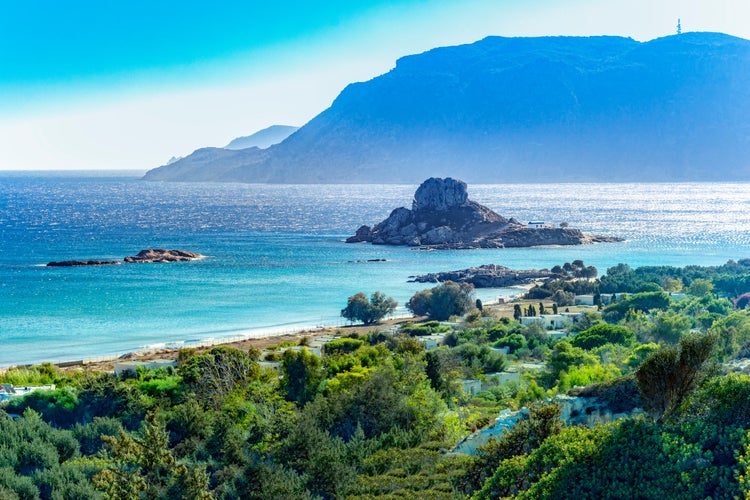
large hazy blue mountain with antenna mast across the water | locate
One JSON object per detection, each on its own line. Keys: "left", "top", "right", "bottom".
{"left": 146, "top": 33, "right": 750, "bottom": 183}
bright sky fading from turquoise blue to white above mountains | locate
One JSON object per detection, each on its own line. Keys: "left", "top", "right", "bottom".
{"left": 0, "top": 0, "right": 750, "bottom": 171}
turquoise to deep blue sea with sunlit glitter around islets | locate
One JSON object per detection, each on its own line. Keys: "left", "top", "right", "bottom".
{"left": 0, "top": 172, "right": 750, "bottom": 367}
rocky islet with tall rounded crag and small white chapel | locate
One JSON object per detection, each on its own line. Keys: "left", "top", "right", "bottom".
{"left": 346, "top": 177, "right": 622, "bottom": 249}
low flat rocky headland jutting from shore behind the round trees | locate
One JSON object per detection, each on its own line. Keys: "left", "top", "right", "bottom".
{"left": 409, "top": 264, "right": 557, "bottom": 288}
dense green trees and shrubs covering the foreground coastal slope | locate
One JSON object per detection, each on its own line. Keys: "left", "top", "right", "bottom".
{"left": 0, "top": 261, "right": 750, "bottom": 499}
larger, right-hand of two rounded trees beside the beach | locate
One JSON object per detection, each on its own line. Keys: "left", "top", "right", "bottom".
{"left": 406, "top": 281, "right": 475, "bottom": 321}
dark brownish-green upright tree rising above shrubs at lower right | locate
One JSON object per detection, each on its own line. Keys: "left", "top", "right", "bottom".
{"left": 635, "top": 334, "right": 716, "bottom": 423}
